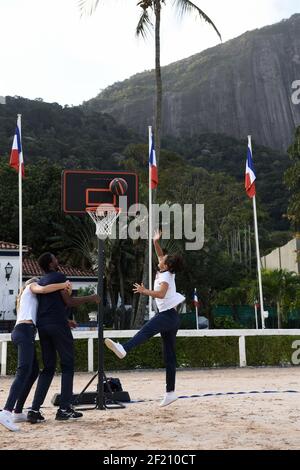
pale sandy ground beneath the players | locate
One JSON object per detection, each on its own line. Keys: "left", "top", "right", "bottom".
{"left": 0, "top": 368, "right": 300, "bottom": 450}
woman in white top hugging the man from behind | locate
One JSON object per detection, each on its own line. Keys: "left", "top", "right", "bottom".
{"left": 0, "top": 278, "right": 71, "bottom": 431}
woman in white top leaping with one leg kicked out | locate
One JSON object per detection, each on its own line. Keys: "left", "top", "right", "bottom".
{"left": 105, "top": 232, "right": 184, "bottom": 406}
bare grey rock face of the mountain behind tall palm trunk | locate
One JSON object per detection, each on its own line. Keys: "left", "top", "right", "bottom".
{"left": 84, "top": 14, "right": 300, "bottom": 150}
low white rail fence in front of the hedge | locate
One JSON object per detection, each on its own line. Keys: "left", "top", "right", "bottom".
{"left": 0, "top": 329, "right": 300, "bottom": 375}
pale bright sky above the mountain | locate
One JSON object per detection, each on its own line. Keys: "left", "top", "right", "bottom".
{"left": 0, "top": 0, "right": 299, "bottom": 105}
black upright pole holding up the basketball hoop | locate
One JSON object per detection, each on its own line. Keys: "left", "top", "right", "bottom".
{"left": 97, "top": 238, "right": 105, "bottom": 410}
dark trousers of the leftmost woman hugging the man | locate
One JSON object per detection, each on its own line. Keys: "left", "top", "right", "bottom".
{"left": 4, "top": 323, "right": 39, "bottom": 413}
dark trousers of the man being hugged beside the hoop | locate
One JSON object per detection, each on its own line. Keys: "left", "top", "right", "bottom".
{"left": 32, "top": 324, "right": 74, "bottom": 411}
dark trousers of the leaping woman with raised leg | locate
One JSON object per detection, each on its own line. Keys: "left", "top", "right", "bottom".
{"left": 122, "top": 308, "right": 180, "bottom": 392}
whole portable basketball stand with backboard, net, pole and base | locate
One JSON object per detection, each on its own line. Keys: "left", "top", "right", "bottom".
{"left": 60, "top": 170, "right": 138, "bottom": 410}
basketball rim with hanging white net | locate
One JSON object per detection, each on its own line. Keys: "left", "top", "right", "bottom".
{"left": 86, "top": 204, "right": 120, "bottom": 238}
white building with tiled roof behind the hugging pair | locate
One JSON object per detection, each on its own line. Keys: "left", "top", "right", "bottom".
{"left": 0, "top": 241, "right": 98, "bottom": 321}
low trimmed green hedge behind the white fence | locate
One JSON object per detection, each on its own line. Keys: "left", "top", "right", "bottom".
{"left": 7, "top": 336, "right": 300, "bottom": 374}
